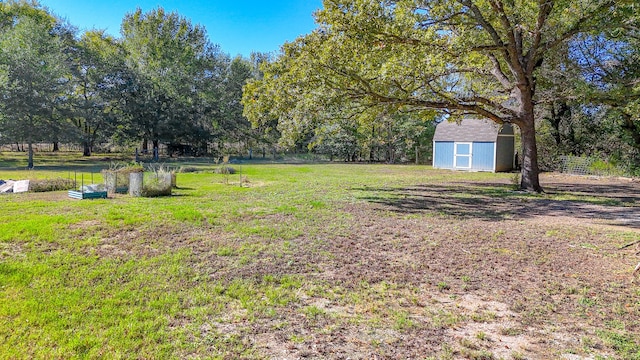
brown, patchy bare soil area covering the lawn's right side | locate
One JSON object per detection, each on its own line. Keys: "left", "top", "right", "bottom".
{"left": 239, "top": 174, "right": 640, "bottom": 359}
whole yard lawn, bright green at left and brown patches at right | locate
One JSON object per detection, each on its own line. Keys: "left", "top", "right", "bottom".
{"left": 0, "top": 155, "right": 640, "bottom": 359}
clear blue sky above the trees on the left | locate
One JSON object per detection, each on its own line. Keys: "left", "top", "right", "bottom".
{"left": 40, "top": 0, "right": 322, "bottom": 57}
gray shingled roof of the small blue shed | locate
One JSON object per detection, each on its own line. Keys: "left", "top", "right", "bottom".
{"left": 433, "top": 119, "right": 513, "bottom": 142}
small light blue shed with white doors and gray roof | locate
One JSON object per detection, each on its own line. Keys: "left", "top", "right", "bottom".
{"left": 433, "top": 119, "right": 515, "bottom": 172}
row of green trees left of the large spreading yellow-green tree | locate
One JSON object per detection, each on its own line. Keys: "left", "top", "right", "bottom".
{"left": 0, "top": 0, "right": 274, "bottom": 168}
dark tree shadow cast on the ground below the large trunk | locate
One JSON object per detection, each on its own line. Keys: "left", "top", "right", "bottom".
{"left": 352, "top": 182, "right": 640, "bottom": 228}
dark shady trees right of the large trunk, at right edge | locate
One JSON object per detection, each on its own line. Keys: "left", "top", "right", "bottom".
{"left": 537, "top": 10, "right": 640, "bottom": 169}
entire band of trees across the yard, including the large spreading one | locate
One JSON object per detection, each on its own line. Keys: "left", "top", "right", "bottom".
{"left": 0, "top": 0, "right": 640, "bottom": 191}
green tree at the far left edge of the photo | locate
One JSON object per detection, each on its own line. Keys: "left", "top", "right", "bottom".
{"left": 0, "top": 2, "right": 68, "bottom": 168}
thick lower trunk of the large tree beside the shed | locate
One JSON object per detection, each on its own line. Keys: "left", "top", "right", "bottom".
{"left": 519, "top": 120, "right": 543, "bottom": 192}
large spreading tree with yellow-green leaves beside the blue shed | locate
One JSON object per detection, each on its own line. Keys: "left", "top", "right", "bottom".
{"left": 245, "top": 0, "right": 632, "bottom": 192}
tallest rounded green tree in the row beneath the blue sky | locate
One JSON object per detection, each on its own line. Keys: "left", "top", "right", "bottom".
{"left": 122, "top": 8, "right": 224, "bottom": 153}
